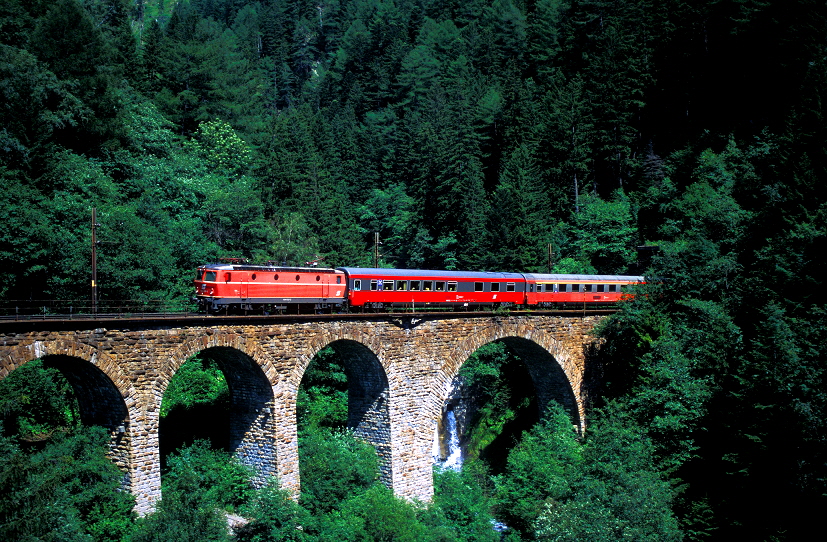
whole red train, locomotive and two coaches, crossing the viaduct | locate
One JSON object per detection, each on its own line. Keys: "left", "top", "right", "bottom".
{"left": 193, "top": 261, "right": 644, "bottom": 314}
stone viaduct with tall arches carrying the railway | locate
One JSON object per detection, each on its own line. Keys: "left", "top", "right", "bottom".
{"left": 0, "top": 313, "right": 603, "bottom": 514}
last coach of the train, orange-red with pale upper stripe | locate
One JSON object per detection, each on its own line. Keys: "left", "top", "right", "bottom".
{"left": 525, "top": 273, "right": 643, "bottom": 307}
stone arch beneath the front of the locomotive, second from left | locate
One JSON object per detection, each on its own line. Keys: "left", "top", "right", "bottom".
{"left": 153, "top": 333, "right": 278, "bottom": 487}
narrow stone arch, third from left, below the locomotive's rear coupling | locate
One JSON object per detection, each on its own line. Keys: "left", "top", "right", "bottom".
{"left": 281, "top": 327, "right": 393, "bottom": 488}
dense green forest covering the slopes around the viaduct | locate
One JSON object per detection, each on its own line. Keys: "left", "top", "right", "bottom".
{"left": 0, "top": 0, "right": 827, "bottom": 540}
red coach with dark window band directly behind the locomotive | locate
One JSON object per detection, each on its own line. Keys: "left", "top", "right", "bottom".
{"left": 339, "top": 267, "right": 525, "bottom": 308}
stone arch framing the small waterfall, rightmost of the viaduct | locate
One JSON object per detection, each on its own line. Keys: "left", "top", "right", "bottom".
{"left": 444, "top": 322, "right": 585, "bottom": 431}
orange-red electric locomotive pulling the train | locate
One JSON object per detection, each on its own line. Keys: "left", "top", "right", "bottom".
{"left": 194, "top": 264, "right": 346, "bottom": 312}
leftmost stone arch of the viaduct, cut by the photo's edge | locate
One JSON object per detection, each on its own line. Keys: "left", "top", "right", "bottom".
{"left": 0, "top": 340, "right": 141, "bottom": 490}
